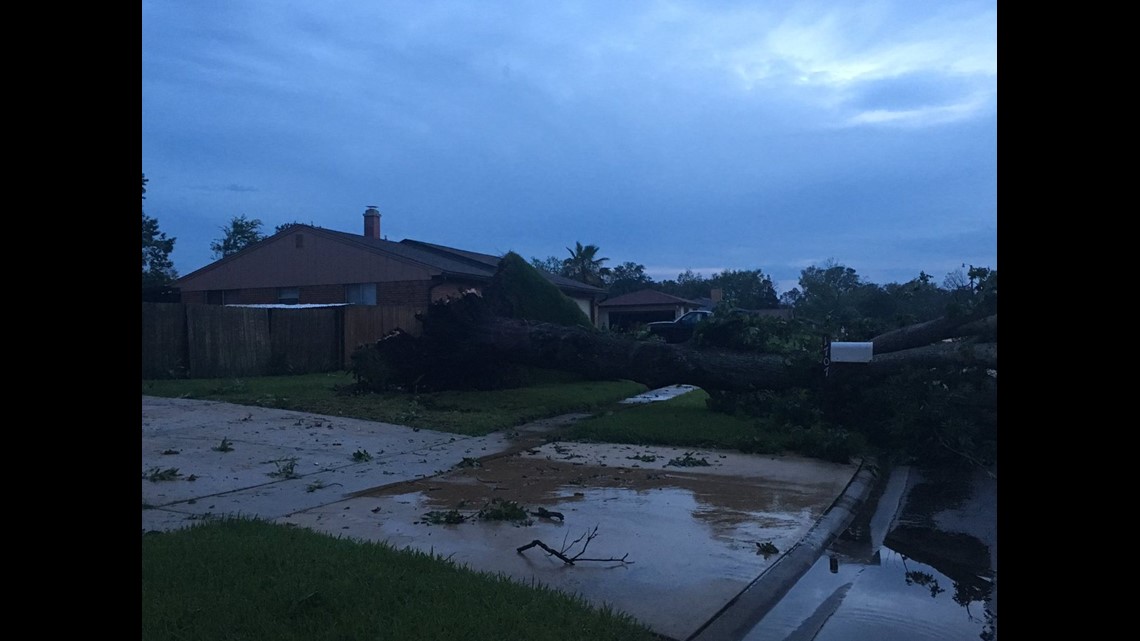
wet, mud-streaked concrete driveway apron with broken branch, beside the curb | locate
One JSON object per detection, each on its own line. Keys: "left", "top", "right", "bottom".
{"left": 286, "top": 443, "right": 855, "bottom": 639}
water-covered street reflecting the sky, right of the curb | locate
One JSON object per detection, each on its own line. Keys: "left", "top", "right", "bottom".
{"left": 744, "top": 460, "right": 998, "bottom": 641}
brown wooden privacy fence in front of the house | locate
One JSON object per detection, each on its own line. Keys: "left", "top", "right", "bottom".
{"left": 143, "top": 302, "right": 423, "bottom": 379}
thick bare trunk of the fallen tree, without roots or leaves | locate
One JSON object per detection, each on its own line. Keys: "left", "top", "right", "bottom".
{"left": 458, "top": 317, "right": 998, "bottom": 391}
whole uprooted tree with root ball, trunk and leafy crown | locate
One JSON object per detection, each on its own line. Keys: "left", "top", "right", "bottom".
{"left": 353, "top": 252, "right": 998, "bottom": 462}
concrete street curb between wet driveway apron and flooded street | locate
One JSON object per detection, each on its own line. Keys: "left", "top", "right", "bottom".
{"left": 685, "top": 460, "right": 879, "bottom": 641}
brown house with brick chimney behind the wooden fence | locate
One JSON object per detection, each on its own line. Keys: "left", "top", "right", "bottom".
{"left": 176, "top": 206, "right": 605, "bottom": 324}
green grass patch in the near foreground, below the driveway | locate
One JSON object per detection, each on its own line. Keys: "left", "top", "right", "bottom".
{"left": 143, "top": 519, "right": 659, "bottom": 641}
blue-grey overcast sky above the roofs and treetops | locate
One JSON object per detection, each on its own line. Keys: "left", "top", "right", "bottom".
{"left": 141, "top": 0, "right": 998, "bottom": 293}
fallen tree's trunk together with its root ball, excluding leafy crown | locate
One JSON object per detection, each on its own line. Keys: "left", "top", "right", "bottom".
{"left": 360, "top": 289, "right": 998, "bottom": 391}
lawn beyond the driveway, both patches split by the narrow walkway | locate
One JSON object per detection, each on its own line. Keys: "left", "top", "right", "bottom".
{"left": 143, "top": 372, "right": 865, "bottom": 453}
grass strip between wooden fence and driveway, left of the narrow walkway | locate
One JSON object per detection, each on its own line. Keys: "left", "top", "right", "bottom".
{"left": 143, "top": 372, "right": 646, "bottom": 436}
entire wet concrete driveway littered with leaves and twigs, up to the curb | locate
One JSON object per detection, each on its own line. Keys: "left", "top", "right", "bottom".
{"left": 143, "top": 388, "right": 860, "bottom": 639}
